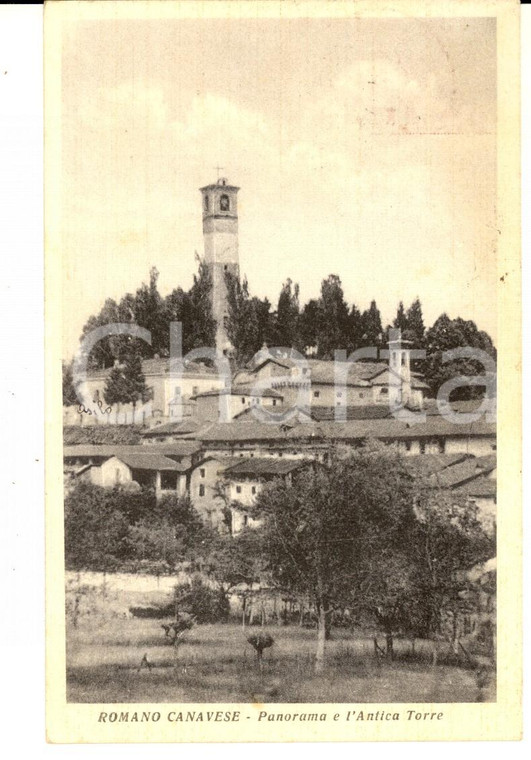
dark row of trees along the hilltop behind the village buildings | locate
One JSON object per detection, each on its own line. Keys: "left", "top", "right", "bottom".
{"left": 65, "top": 261, "right": 496, "bottom": 403}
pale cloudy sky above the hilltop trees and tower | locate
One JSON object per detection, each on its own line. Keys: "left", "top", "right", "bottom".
{"left": 61, "top": 18, "right": 497, "bottom": 357}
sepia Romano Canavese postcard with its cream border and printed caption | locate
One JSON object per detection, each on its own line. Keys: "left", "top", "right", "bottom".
{"left": 45, "top": 0, "right": 520, "bottom": 741}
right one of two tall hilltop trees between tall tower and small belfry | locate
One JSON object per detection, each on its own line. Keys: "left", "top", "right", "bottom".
{"left": 317, "top": 274, "right": 349, "bottom": 359}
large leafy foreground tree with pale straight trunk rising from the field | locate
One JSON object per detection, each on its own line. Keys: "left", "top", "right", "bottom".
{"left": 252, "top": 451, "right": 414, "bottom": 673}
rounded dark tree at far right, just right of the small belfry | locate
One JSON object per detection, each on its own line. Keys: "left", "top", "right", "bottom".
{"left": 425, "top": 314, "right": 496, "bottom": 400}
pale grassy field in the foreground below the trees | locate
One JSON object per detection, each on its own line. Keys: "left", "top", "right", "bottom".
{"left": 67, "top": 617, "right": 495, "bottom": 703}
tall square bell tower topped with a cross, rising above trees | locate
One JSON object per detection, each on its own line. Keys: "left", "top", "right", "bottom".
{"left": 201, "top": 177, "right": 240, "bottom": 353}
